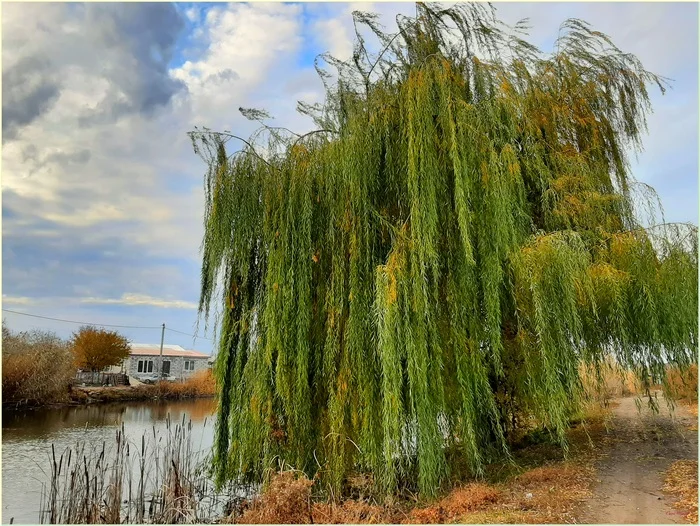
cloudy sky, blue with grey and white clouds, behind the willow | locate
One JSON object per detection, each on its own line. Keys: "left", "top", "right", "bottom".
{"left": 2, "top": 2, "right": 698, "bottom": 353}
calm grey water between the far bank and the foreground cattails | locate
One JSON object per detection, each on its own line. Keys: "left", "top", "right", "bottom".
{"left": 2, "top": 399, "right": 216, "bottom": 524}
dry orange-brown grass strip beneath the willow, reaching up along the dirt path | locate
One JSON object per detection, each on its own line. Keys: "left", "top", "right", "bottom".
{"left": 225, "top": 405, "right": 610, "bottom": 524}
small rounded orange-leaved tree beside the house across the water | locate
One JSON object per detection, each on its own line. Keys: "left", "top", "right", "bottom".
{"left": 70, "top": 327, "right": 131, "bottom": 371}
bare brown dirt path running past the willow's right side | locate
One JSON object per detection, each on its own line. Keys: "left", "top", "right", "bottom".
{"left": 580, "top": 394, "right": 698, "bottom": 524}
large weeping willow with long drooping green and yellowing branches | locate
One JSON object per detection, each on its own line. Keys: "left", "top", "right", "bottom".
{"left": 191, "top": 4, "right": 698, "bottom": 496}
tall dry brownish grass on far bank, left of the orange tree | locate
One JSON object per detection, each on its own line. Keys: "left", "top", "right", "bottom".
{"left": 2, "top": 324, "right": 76, "bottom": 405}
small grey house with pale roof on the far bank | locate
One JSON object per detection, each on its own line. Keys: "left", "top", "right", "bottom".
{"left": 124, "top": 343, "right": 209, "bottom": 380}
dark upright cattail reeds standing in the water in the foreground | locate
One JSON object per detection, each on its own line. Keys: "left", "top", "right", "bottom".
{"left": 40, "top": 417, "right": 254, "bottom": 524}
